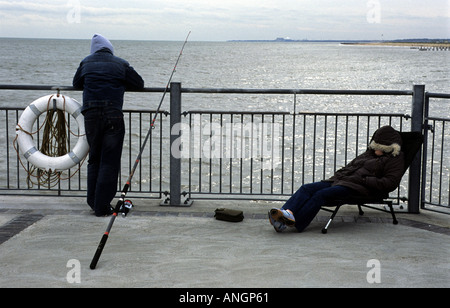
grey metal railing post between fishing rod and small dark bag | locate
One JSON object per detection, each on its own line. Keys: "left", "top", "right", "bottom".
{"left": 161, "top": 82, "right": 192, "bottom": 206}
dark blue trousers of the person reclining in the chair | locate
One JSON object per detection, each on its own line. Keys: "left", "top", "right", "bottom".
{"left": 283, "top": 182, "right": 355, "bottom": 232}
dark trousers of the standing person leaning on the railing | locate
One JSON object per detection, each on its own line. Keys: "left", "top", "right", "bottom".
{"left": 84, "top": 108, "right": 125, "bottom": 216}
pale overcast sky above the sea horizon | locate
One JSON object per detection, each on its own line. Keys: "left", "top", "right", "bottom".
{"left": 0, "top": 0, "right": 450, "bottom": 41}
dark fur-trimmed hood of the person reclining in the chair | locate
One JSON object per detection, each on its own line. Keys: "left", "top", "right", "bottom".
{"left": 369, "top": 126, "right": 402, "bottom": 156}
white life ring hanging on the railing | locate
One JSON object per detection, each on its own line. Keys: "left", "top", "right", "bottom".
{"left": 16, "top": 94, "right": 89, "bottom": 171}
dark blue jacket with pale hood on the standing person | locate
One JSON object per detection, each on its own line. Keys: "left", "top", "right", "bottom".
{"left": 73, "top": 34, "right": 144, "bottom": 113}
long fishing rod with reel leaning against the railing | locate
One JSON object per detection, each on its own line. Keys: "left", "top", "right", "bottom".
{"left": 90, "top": 31, "right": 191, "bottom": 270}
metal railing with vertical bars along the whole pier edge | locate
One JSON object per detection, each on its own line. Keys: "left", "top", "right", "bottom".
{"left": 0, "top": 83, "right": 450, "bottom": 212}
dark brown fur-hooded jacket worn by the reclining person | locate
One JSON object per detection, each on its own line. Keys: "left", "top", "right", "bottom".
{"left": 328, "top": 126, "right": 405, "bottom": 197}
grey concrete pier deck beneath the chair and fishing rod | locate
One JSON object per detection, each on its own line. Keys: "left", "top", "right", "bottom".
{"left": 0, "top": 196, "right": 450, "bottom": 288}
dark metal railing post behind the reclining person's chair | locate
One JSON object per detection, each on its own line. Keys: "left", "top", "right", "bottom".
{"left": 408, "top": 85, "right": 425, "bottom": 214}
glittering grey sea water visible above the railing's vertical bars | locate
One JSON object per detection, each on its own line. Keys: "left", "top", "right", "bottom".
{"left": 0, "top": 38, "right": 450, "bottom": 114}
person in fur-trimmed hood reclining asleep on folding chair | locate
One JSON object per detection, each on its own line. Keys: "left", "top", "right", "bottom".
{"left": 269, "top": 126, "right": 404, "bottom": 232}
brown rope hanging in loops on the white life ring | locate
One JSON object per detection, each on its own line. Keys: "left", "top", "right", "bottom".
{"left": 13, "top": 93, "right": 86, "bottom": 188}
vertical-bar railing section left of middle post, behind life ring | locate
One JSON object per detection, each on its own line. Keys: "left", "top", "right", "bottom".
{"left": 0, "top": 108, "right": 170, "bottom": 198}
